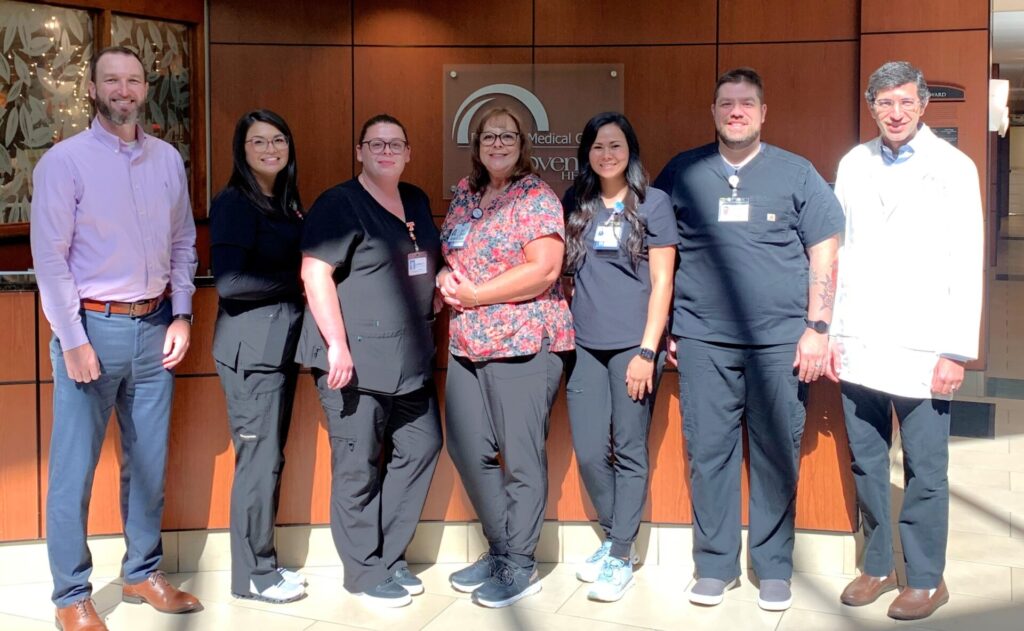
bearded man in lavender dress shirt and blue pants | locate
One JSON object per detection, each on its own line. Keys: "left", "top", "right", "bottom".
{"left": 31, "top": 47, "right": 200, "bottom": 631}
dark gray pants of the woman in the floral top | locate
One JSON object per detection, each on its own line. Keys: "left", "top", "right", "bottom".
{"left": 444, "top": 340, "right": 563, "bottom": 571}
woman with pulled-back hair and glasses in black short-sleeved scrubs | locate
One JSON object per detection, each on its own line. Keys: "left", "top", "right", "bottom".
{"left": 297, "top": 114, "right": 441, "bottom": 607}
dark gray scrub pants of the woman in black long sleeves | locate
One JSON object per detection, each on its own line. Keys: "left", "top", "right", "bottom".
{"left": 215, "top": 362, "right": 299, "bottom": 595}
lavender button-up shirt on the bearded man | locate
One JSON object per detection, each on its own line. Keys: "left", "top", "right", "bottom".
{"left": 30, "top": 120, "right": 197, "bottom": 350}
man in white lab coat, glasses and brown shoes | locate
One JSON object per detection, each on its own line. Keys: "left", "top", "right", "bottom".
{"left": 827, "top": 61, "right": 983, "bottom": 620}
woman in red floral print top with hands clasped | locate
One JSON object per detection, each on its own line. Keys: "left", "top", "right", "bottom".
{"left": 437, "top": 109, "right": 573, "bottom": 606}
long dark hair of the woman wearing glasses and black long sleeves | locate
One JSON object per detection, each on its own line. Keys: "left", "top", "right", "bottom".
{"left": 227, "top": 110, "right": 303, "bottom": 217}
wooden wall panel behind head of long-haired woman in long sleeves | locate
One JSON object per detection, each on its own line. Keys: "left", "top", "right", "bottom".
{"left": 210, "top": 44, "right": 352, "bottom": 212}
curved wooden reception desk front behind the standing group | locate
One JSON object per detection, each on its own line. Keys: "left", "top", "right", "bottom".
{"left": 0, "top": 277, "right": 856, "bottom": 541}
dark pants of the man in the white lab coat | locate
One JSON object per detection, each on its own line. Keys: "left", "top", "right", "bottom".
{"left": 842, "top": 381, "right": 949, "bottom": 589}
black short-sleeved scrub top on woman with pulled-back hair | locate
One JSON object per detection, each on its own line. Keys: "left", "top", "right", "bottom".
{"left": 297, "top": 179, "right": 441, "bottom": 394}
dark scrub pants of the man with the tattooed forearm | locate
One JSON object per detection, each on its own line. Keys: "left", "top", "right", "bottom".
{"left": 676, "top": 338, "right": 807, "bottom": 581}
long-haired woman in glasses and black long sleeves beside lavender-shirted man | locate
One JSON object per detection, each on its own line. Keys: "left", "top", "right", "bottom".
{"left": 210, "top": 110, "right": 305, "bottom": 602}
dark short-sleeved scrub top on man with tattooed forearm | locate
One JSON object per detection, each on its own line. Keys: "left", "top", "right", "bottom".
{"left": 653, "top": 143, "right": 844, "bottom": 345}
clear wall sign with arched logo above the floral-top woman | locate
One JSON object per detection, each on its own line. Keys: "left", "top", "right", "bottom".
{"left": 441, "top": 64, "right": 625, "bottom": 199}
